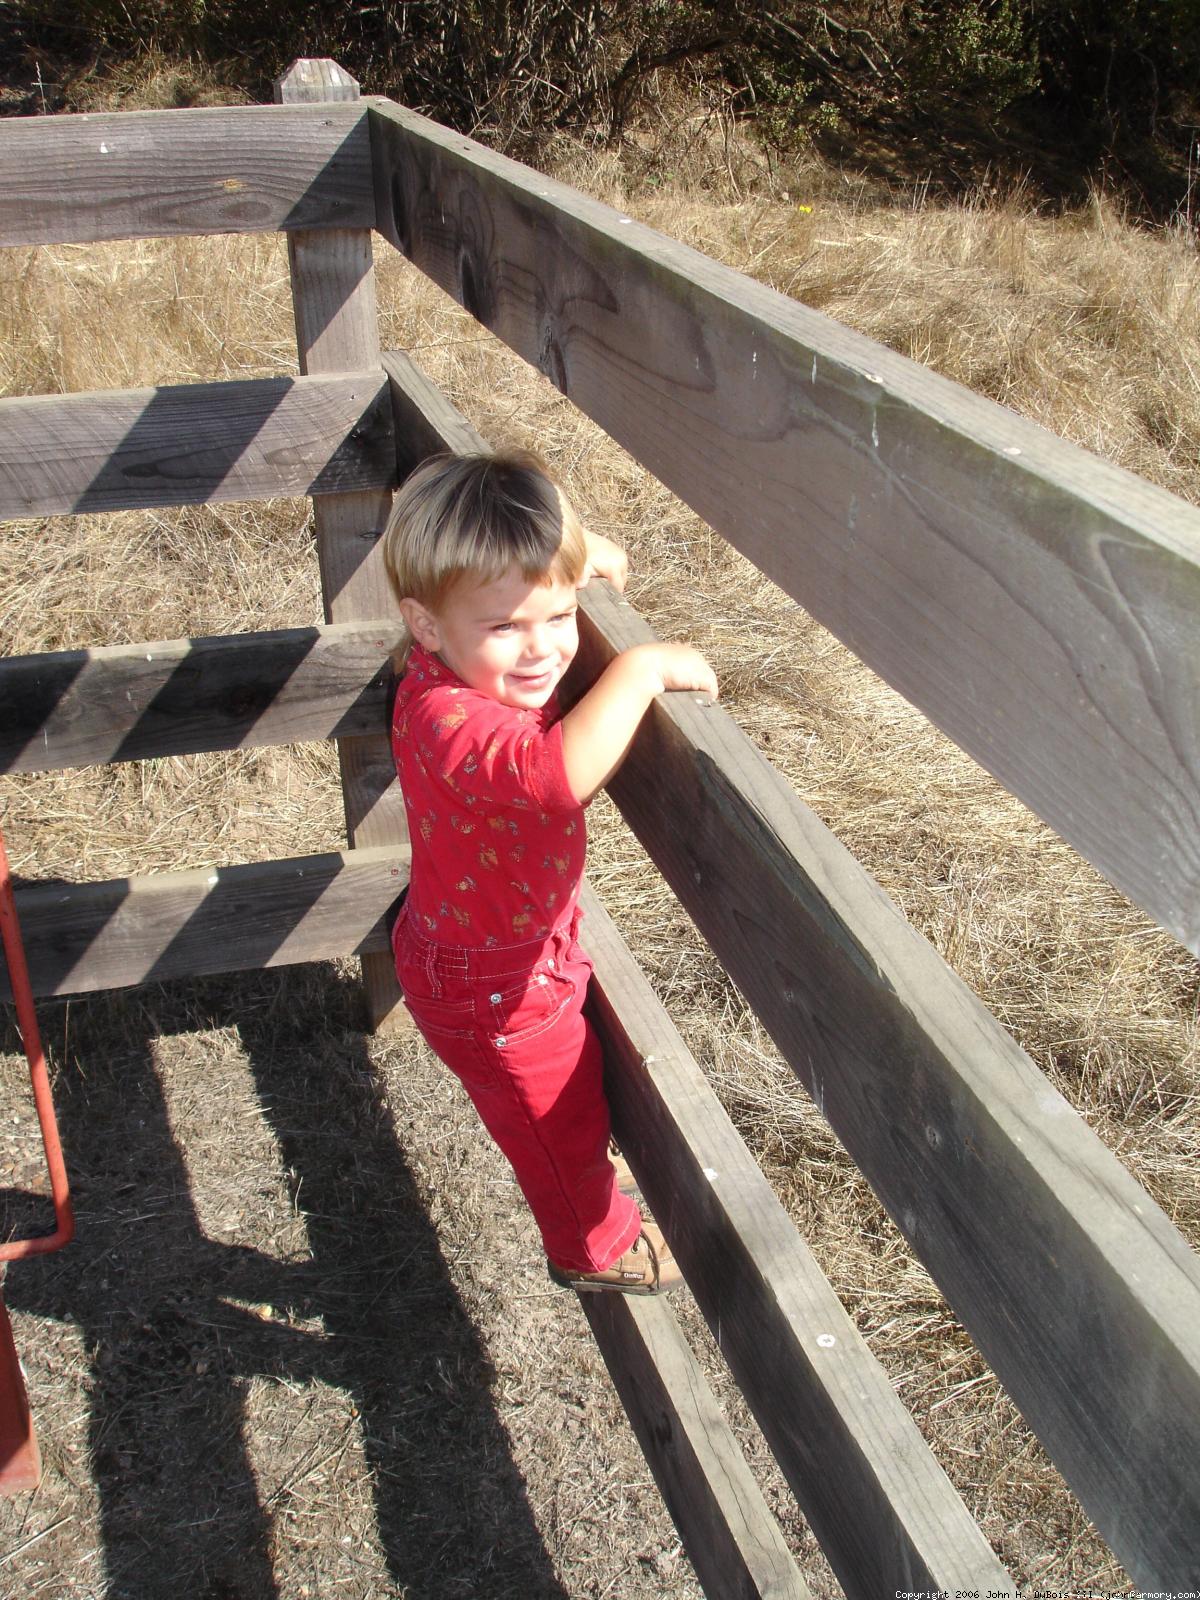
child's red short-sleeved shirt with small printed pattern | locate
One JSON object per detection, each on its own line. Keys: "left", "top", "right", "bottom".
{"left": 392, "top": 645, "right": 587, "bottom": 946}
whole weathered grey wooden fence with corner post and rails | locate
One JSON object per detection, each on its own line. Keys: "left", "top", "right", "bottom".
{"left": 0, "top": 62, "right": 1200, "bottom": 1600}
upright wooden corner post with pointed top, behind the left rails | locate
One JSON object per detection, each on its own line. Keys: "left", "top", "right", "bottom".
{"left": 275, "top": 59, "right": 408, "bottom": 1029}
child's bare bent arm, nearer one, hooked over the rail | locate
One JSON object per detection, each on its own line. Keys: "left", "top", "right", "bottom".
{"left": 562, "top": 645, "right": 717, "bottom": 805}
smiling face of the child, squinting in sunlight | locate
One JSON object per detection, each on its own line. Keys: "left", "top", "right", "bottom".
{"left": 402, "top": 566, "right": 579, "bottom": 710}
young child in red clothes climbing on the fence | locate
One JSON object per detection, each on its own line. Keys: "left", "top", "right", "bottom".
{"left": 384, "top": 451, "right": 717, "bottom": 1294}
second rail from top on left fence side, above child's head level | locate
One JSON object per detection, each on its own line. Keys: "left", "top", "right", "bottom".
{"left": 0, "top": 369, "right": 395, "bottom": 517}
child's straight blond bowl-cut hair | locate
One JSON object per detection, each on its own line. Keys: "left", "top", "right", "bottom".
{"left": 384, "top": 450, "right": 587, "bottom": 667}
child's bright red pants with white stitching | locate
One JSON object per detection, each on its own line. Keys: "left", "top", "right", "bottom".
{"left": 392, "top": 910, "right": 642, "bottom": 1272}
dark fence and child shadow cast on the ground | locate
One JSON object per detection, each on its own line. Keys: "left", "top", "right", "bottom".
{"left": 6, "top": 966, "right": 565, "bottom": 1600}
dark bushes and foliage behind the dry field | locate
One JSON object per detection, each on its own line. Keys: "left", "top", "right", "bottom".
{"left": 0, "top": 0, "right": 1200, "bottom": 185}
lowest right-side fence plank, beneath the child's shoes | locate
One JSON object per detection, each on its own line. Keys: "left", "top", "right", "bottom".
{"left": 579, "top": 1294, "right": 811, "bottom": 1600}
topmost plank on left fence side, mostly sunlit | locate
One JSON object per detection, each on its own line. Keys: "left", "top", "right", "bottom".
{"left": 0, "top": 104, "right": 374, "bottom": 245}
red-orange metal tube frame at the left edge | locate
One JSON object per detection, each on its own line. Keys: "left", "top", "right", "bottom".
{"left": 0, "top": 832, "right": 75, "bottom": 1494}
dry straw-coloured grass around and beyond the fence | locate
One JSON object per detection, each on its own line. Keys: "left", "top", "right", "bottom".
{"left": 0, "top": 128, "right": 1200, "bottom": 1595}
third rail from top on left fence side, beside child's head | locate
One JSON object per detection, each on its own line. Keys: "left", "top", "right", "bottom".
{"left": 0, "top": 622, "right": 403, "bottom": 773}
